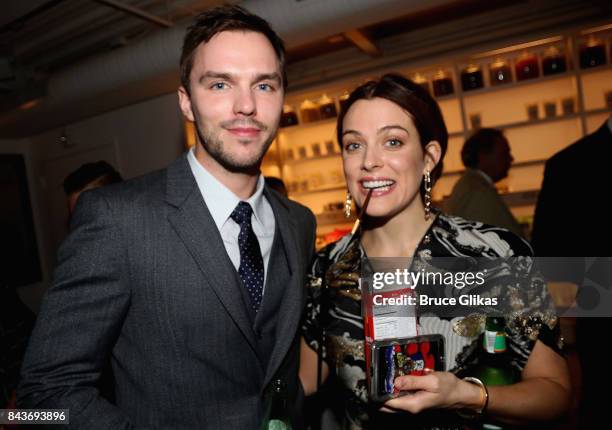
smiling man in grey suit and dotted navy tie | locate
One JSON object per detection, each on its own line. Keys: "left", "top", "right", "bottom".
{"left": 19, "top": 6, "right": 315, "bottom": 429}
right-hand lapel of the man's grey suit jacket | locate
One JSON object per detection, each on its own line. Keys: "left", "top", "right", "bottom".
{"left": 264, "top": 187, "right": 306, "bottom": 387}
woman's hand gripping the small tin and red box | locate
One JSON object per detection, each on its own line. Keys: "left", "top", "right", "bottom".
{"left": 385, "top": 371, "right": 483, "bottom": 414}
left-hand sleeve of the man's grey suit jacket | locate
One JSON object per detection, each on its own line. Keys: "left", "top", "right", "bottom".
{"left": 18, "top": 190, "right": 133, "bottom": 429}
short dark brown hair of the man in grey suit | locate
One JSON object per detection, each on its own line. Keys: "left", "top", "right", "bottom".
{"left": 180, "top": 5, "right": 287, "bottom": 94}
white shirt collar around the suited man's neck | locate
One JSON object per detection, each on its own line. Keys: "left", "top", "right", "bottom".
{"left": 187, "top": 148, "right": 265, "bottom": 230}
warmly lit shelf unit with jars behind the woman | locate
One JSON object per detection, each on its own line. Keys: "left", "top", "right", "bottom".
{"left": 263, "top": 26, "right": 612, "bottom": 245}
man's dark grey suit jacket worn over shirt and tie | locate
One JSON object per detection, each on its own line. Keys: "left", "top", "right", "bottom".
{"left": 18, "top": 156, "right": 315, "bottom": 430}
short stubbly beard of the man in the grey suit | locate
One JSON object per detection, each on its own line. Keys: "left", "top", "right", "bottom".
{"left": 195, "top": 117, "right": 276, "bottom": 174}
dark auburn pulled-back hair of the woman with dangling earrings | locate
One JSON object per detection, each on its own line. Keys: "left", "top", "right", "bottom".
{"left": 336, "top": 73, "right": 448, "bottom": 191}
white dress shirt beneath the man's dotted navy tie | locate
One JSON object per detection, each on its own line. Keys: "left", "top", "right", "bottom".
{"left": 187, "top": 148, "right": 276, "bottom": 286}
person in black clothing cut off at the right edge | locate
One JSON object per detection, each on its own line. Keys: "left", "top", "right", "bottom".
{"left": 532, "top": 117, "right": 612, "bottom": 429}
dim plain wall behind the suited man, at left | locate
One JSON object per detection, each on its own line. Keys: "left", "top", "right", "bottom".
{"left": 0, "top": 93, "right": 184, "bottom": 310}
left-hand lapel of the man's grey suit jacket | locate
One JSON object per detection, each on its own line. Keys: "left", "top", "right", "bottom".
{"left": 166, "top": 156, "right": 257, "bottom": 358}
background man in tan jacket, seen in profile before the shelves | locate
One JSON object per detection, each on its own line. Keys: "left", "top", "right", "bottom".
{"left": 446, "top": 128, "right": 523, "bottom": 236}
